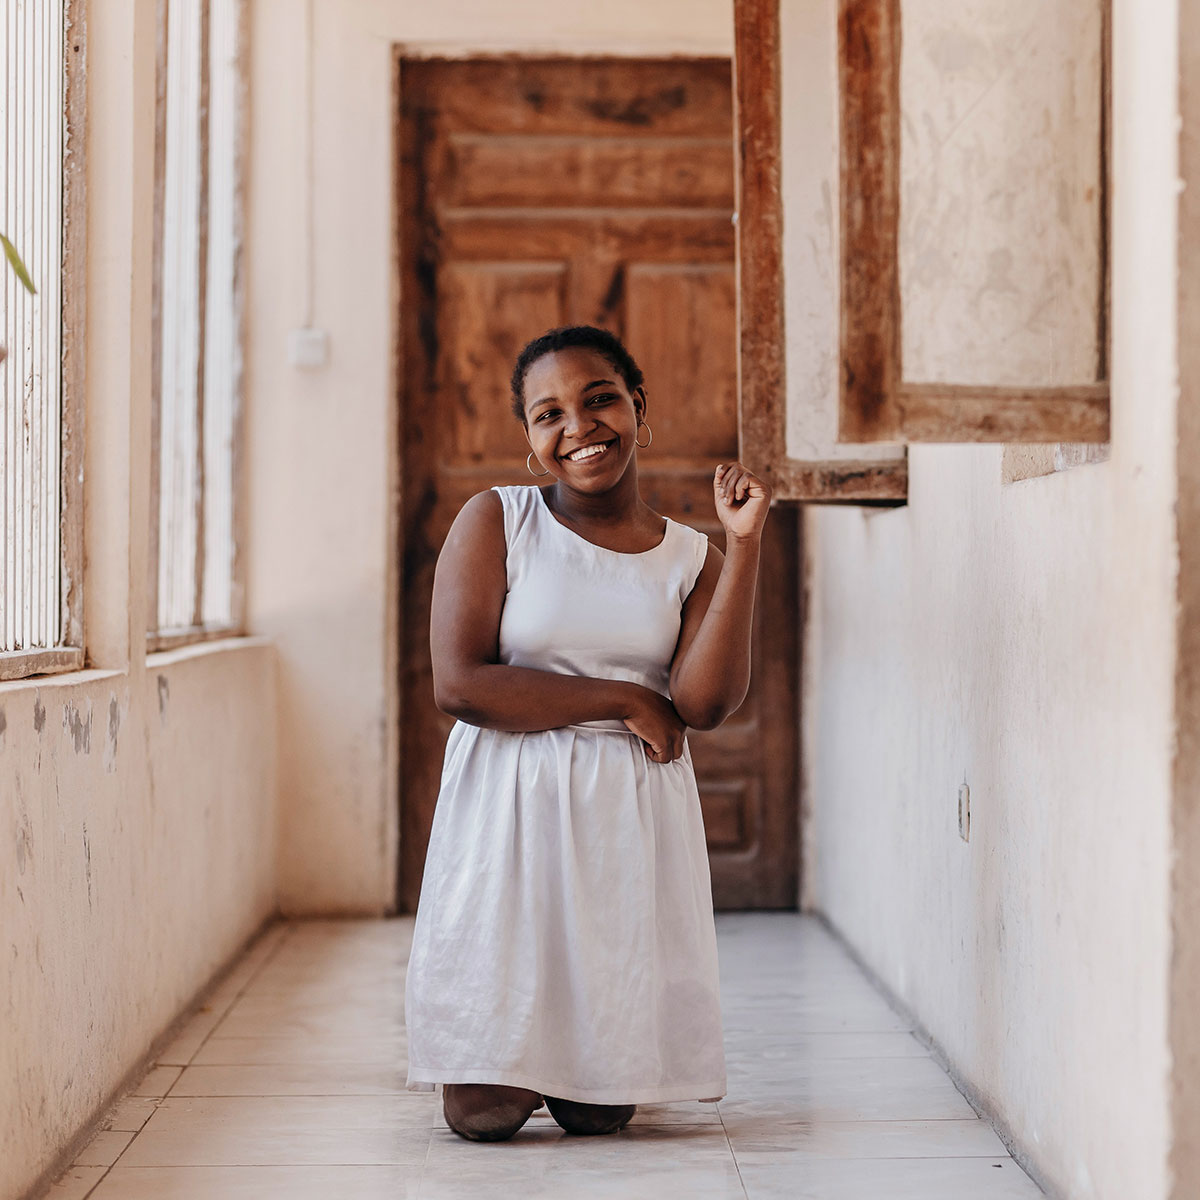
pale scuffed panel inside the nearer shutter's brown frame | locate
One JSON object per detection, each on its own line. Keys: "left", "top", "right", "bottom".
{"left": 899, "top": 0, "right": 1106, "bottom": 385}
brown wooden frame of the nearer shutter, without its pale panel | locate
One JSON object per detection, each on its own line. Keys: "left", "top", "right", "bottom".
{"left": 838, "top": 0, "right": 1112, "bottom": 443}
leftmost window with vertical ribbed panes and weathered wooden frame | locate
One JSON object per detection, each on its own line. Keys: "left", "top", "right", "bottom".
{"left": 0, "top": 2, "right": 83, "bottom": 679}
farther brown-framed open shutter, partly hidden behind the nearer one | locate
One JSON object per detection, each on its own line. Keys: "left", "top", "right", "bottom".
{"left": 734, "top": 0, "right": 907, "bottom": 504}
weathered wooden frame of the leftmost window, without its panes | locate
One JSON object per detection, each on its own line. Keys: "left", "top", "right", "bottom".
{"left": 0, "top": 0, "right": 88, "bottom": 682}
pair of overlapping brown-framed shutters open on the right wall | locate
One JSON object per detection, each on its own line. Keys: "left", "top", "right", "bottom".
{"left": 734, "top": 0, "right": 1110, "bottom": 504}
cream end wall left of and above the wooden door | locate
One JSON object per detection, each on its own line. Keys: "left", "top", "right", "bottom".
{"left": 246, "top": 0, "right": 732, "bottom": 913}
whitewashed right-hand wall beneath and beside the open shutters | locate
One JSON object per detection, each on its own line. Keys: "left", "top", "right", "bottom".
{"left": 804, "top": 0, "right": 1176, "bottom": 1200}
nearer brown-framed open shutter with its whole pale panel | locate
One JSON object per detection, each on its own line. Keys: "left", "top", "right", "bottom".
{"left": 835, "top": 0, "right": 1110, "bottom": 443}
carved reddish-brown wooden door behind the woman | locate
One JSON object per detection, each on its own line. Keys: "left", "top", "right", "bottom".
{"left": 398, "top": 59, "right": 800, "bottom": 911}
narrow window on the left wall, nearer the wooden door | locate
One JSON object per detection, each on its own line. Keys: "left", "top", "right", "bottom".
{"left": 148, "top": 0, "right": 244, "bottom": 649}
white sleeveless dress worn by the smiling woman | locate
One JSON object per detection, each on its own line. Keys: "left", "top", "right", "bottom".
{"left": 404, "top": 486, "right": 725, "bottom": 1104}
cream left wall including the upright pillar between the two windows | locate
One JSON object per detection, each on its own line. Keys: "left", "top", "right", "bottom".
{"left": 0, "top": 0, "right": 276, "bottom": 1200}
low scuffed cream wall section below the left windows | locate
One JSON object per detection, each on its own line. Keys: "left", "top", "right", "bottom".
{"left": 0, "top": 640, "right": 276, "bottom": 1200}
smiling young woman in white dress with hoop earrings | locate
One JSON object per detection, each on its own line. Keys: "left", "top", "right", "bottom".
{"left": 406, "top": 325, "right": 770, "bottom": 1140}
